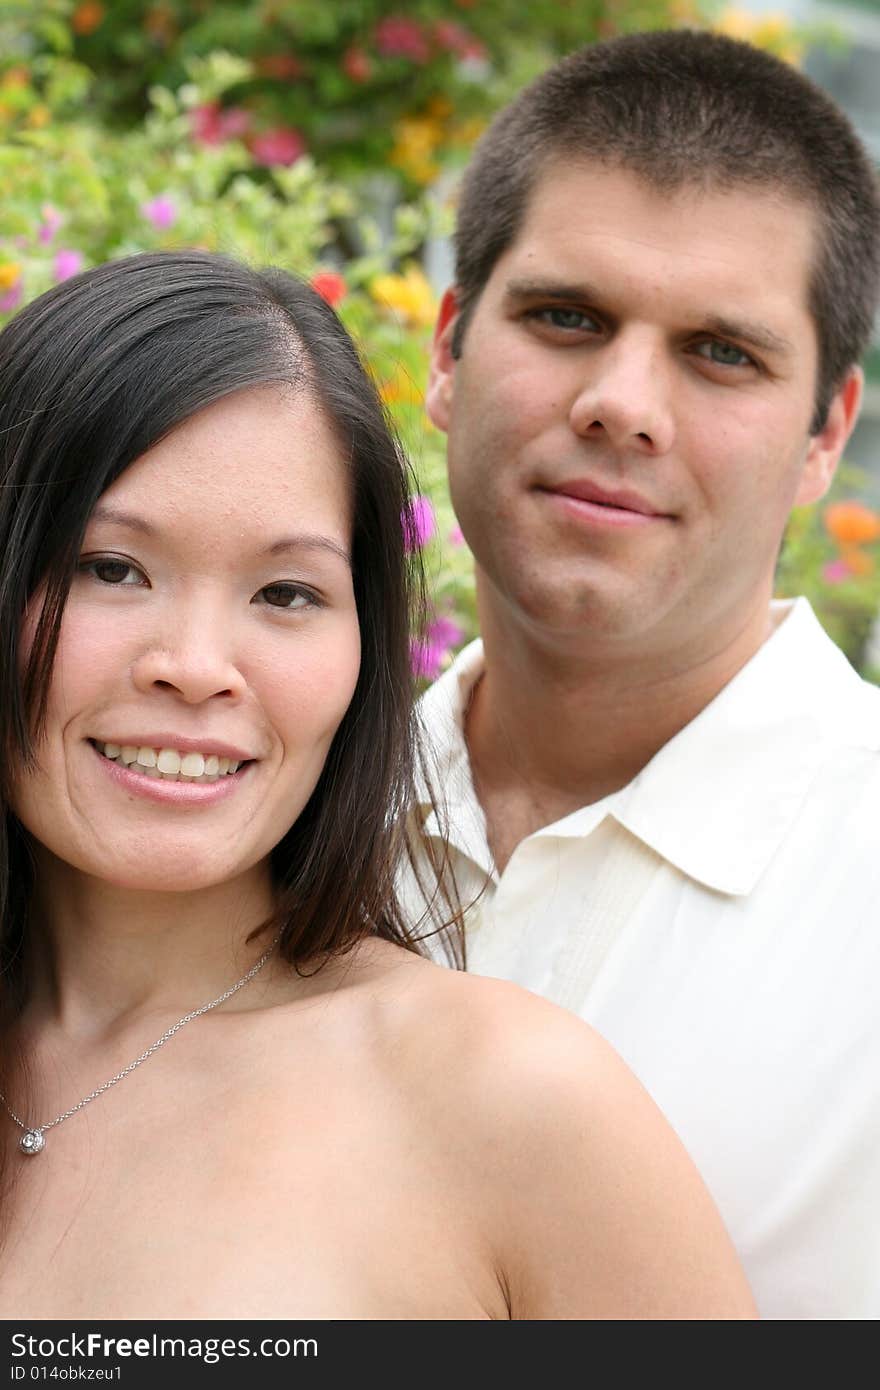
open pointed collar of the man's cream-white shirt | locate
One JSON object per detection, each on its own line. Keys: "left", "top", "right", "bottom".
{"left": 414, "top": 599, "right": 880, "bottom": 895}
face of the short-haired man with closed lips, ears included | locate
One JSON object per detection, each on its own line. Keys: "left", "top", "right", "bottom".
{"left": 428, "top": 163, "right": 859, "bottom": 655}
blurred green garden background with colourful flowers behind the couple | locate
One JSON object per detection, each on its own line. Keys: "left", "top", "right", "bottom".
{"left": 0, "top": 0, "right": 880, "bottom": 682}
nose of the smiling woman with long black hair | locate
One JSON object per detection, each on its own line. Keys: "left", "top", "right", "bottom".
{"left": 132, "top": 603, "right": 246, "bottom": 705}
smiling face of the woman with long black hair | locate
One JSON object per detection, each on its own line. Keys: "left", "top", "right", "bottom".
{"left": 13, "top": 386, "right": 360, "bottom": 891}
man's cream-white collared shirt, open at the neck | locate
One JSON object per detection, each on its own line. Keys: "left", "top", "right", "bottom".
{"left": 405, "top": 599, "right": 880, "bottom": 1319}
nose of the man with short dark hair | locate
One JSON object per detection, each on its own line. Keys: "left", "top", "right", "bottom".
{"left": 570, "top": 331, "right": 676, "bottom": 455}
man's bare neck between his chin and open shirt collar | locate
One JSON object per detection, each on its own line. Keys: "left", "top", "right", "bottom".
{"left": 466, "top": 600, "right": 772, "bottom": 872}
